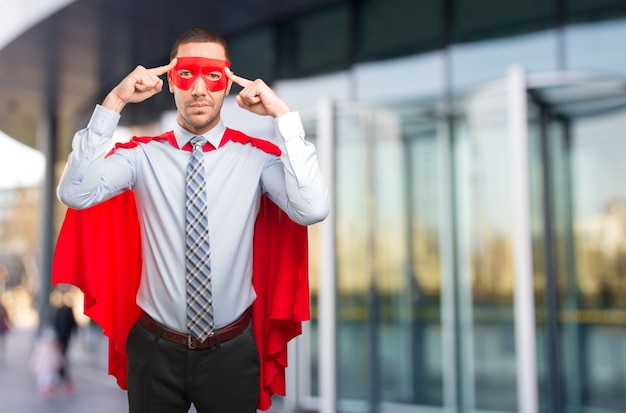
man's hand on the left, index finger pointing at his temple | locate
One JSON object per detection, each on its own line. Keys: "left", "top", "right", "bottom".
{"left": 102, "top": 59, "right": 177, "bottom": 113}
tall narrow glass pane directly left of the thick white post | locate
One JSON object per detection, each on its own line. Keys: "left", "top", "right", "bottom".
{"left": 455, "top": 88, "right": 517, "bottom": 411}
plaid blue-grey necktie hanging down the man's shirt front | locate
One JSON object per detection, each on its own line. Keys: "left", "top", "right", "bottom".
{"left": 185, "top": 136, "right": 214, "bottom": 341}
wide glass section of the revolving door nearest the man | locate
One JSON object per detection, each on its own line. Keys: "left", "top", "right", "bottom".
{"left": 336, "top": 103, "right": 450, "bottom": 406}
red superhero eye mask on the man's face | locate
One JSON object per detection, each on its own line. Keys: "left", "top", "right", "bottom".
{"left": 170, "top": 57, "right": 230, "bottom": 92}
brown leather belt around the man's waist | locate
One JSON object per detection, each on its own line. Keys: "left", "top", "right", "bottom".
{"left": 139, "top": 308, "right": 251, "bottom": 350}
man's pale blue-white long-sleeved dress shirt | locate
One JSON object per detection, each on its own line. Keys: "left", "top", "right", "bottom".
{"left": 57, "top": 105, "right": 328, "bottom": 332}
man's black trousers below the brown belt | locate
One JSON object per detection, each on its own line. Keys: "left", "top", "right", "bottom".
{"left": 126, "top": 322, "right": 260, "bottom": 413}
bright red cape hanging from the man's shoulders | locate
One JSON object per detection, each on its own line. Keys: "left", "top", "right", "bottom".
{"left": 52, "top": 129, "right": 310, "bottom": 410}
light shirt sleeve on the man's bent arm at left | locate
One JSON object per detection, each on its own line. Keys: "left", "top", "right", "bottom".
{"left": 57, "top": 105, "right": 133, "bottom": 209}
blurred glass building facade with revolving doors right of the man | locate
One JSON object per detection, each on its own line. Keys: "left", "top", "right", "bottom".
{"left": 221, "top": 0, "right": 626, "bottom": 413}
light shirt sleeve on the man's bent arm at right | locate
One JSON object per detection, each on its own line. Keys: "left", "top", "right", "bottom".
{"left": 263, "top": 112, "right": 328, "bottom": 225}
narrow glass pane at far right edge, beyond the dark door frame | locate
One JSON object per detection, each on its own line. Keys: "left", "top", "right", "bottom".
{"left": 563, "top": 110, "right": 626, "bottom": 411}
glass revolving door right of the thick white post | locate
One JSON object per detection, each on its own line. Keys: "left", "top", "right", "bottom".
{"left": 530, "top": 81, "right": 626, "bottom": 412}
